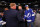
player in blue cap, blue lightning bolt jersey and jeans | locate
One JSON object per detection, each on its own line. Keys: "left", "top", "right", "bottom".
{"left": 24, "top": 5, "right": 35, "bottom": 27}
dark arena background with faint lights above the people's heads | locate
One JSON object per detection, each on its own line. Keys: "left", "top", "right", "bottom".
{"left": 0, "top": 0, "right": 40, "bottom": 10}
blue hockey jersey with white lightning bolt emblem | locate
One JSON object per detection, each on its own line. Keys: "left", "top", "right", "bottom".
{"left": 24, "top": 9, "right": 35, "bottom": 22}
